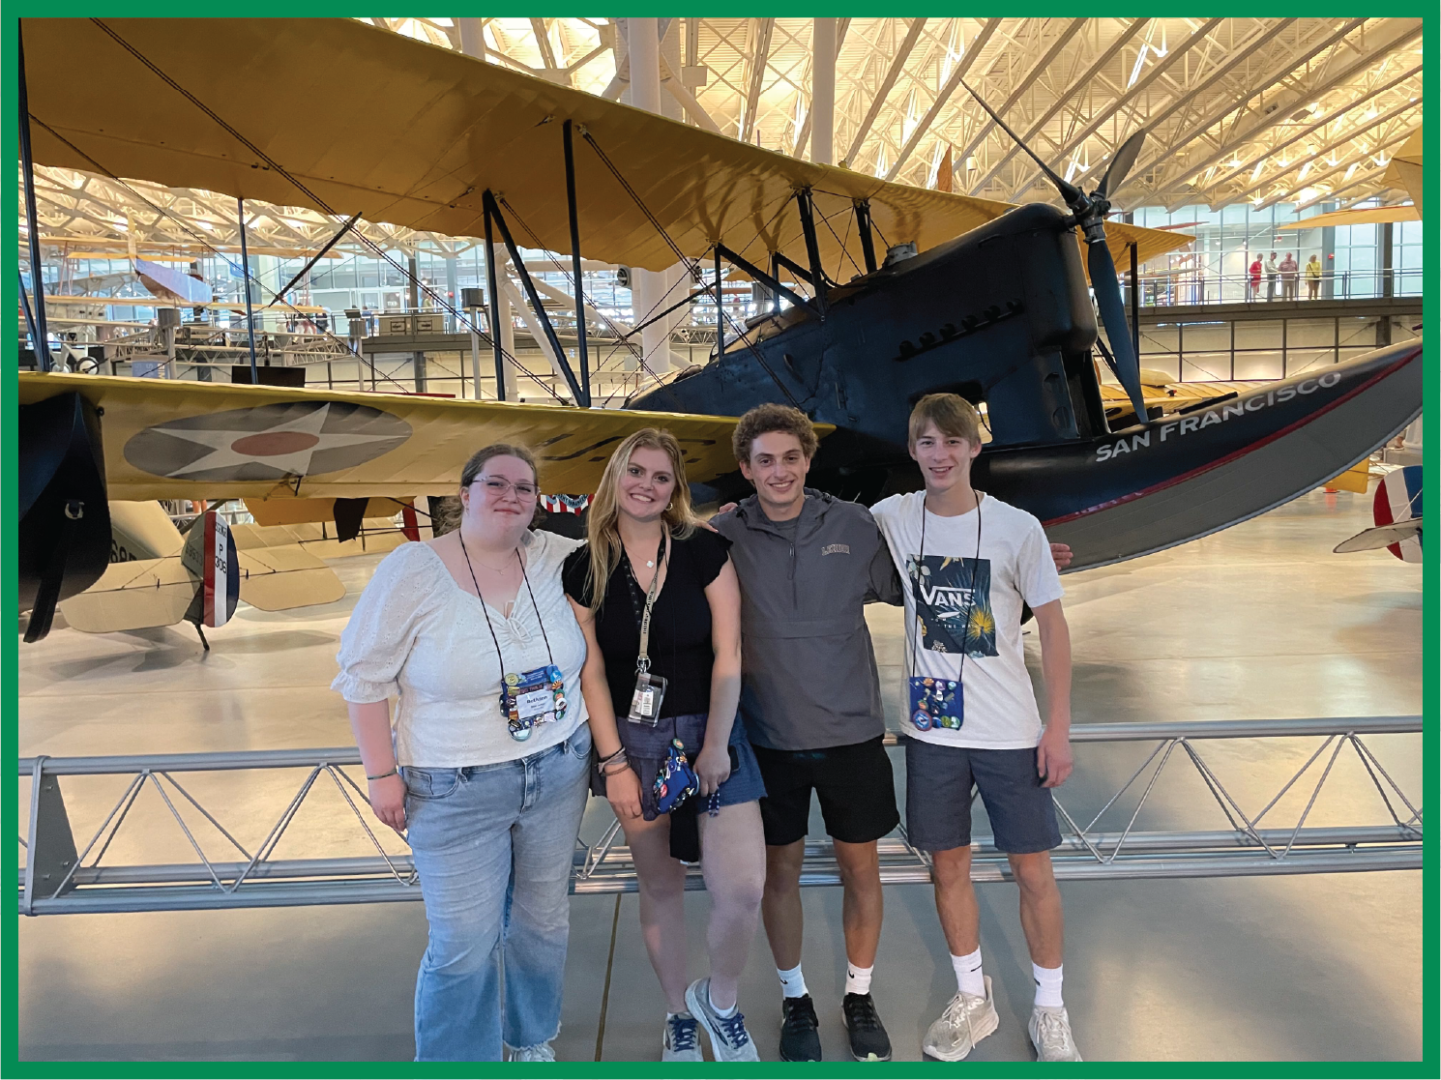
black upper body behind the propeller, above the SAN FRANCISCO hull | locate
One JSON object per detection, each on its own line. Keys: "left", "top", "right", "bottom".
{"left": 627, "top": 203, "right": 1105, "bottom": 495}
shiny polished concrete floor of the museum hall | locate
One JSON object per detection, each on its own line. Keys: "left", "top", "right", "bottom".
{"left": 19, "top": 493, "right": 1422, "bottom": 1061}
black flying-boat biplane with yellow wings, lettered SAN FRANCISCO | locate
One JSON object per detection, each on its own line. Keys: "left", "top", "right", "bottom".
{"left": 19, "top": 19, "right": 1421, "bottom": 637}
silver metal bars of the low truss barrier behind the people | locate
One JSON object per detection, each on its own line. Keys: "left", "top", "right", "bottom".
{"left": 19, "top": 717, "right": 1422, "bottom": 916}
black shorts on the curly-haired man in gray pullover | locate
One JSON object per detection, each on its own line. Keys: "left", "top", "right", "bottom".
{"left": 755, "top": 735, "right": 901, "bottom": 846}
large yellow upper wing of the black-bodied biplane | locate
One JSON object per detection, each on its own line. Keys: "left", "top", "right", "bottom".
{"left": 24, "top": 19, "right": 1190, "bottom": 281}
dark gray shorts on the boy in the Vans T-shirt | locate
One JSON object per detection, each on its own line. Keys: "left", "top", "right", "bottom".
{"left": 905, "top": 738, "right": 1061, "bottom": 855}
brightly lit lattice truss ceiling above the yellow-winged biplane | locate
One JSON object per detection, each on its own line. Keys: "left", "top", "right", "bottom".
{"left": 22, "top": 17, "right": 1422, "bottom": 257}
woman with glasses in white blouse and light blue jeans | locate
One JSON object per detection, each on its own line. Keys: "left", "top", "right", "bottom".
{"left": 333, "top": 444, "right": 591, "bottom": 1061}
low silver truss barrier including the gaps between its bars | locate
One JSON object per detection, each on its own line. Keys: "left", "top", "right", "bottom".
{"left": 19, "top": 717, "right": 1422, "bottom": 916}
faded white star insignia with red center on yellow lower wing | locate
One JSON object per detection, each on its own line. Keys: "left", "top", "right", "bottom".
{"left": 125, "top": 401, "right": 411, "bottom": 480}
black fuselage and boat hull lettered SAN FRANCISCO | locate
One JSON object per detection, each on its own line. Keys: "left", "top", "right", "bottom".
{"left": 627, "top": 203, "right": 1421, "bottom": 570}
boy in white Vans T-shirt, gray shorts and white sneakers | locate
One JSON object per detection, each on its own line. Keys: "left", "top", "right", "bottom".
{"left": 872, "top": 394, "right": 1081, "bottom": 1061}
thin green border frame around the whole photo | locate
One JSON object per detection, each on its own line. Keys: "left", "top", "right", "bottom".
{"left": 0, "top": 0, "right": 1441, "bottom": 1080}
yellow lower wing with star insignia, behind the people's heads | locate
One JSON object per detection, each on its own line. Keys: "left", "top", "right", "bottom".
{"left": 19, "top": 372, "right": 778, "bottom": 499}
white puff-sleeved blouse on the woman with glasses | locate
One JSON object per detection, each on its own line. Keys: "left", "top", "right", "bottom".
{"left": 330, "top": 532, "right": 586, "bottom": 769}
